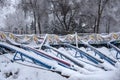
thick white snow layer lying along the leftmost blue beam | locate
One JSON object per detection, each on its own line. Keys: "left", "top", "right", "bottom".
{"left": 0, "top": 42, "right": 82, "bottom": 76}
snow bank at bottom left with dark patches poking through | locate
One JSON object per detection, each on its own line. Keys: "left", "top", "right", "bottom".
{"left": 0, "top": 55, "right": 67, "bottom": 80}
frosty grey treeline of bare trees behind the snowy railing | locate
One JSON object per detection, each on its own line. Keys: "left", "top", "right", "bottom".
{"left": 0, "top": 0, "right": 120, "bottom": 34}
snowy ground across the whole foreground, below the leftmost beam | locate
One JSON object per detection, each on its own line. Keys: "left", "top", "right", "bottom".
{"left": 0, "top": 48, "right": 120, "bottom": 80}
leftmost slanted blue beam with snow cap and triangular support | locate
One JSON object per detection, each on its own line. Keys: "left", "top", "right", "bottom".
{"left": 0, "top": 42, "right": 57, "bottom": 70}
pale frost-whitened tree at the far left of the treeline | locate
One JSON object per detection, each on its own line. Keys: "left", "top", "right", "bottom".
{"left": 5, "top": 9, "right": 30, "bottom": 32}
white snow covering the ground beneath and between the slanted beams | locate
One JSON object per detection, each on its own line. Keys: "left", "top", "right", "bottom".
{"left": 0, "top": 32, "right": 120, "bottom": 80}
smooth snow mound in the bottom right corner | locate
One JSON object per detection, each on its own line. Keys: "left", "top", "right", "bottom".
{"left": 69, "top": 67, "right": 120, "bottom": 80}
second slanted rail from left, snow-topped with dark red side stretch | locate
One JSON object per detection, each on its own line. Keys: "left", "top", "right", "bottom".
{"left": 4, "top": 36, "right": 77, "bottom": 70}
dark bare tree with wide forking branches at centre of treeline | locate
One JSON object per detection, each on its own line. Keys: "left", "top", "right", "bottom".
{"left": 50, "top": 0, "right": 79, "bottom": 33}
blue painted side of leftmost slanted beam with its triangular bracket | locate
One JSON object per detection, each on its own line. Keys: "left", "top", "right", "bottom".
{"left": 0, "top": 42, "right": 55, "bottom": 70}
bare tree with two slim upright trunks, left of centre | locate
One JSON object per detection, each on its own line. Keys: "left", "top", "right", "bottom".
{"left": 20, "top": 0, "right": 47, "bottom": 34}
